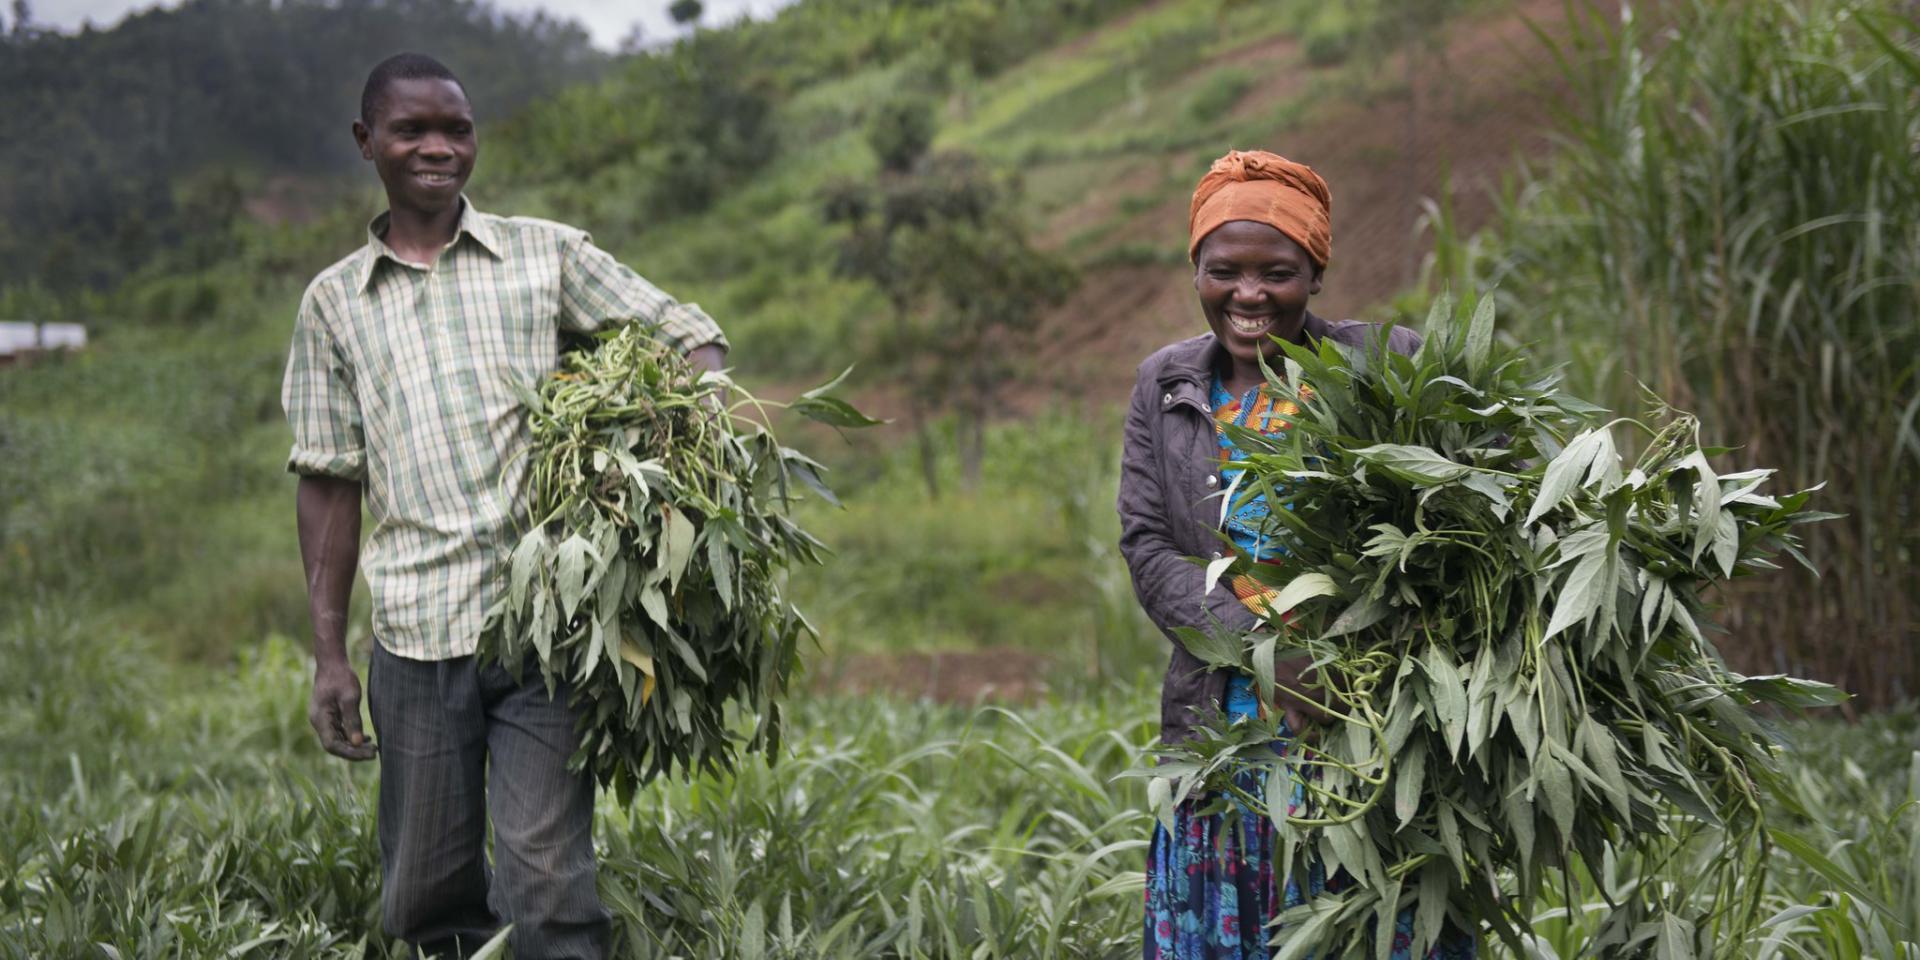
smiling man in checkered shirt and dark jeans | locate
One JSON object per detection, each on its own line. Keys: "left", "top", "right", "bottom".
{"left": 282, "top": 54, "right": 726, "bottom": 960}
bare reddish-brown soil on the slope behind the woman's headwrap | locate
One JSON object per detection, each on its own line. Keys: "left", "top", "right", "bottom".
{"left": 1012, "top": 0, "right": 1597, "bottom": 413}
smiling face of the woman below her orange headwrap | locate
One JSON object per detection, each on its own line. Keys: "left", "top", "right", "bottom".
{"left": 1194, "top": 221, "right": 1319, "bottom": 369}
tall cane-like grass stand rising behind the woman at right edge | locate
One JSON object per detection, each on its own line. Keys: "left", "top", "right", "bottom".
{"left": 1444, "top": 0, "right": 1920, "bottom": 703}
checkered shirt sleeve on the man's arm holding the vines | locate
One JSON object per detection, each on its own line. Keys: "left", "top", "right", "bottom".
{"left": 561, "top": 232, "right": 728, "bottom": 353}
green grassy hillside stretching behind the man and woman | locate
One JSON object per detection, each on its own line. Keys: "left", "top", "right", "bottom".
{"left": 0, "top": 0, "right": 1451, "bottom": 668}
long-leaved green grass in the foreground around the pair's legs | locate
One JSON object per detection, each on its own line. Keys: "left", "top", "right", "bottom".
{"left": 0, "top": 605, "right": 1920, "bottom": 960}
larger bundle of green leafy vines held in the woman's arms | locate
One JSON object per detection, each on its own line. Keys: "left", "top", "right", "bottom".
{"left": 1142, "top": 298, "right": 1839, "bottom": 960}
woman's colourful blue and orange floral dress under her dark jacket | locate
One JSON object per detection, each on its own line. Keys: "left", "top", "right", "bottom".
{"left": 1144, "top": 376, "right": 1475, "bottom": 960}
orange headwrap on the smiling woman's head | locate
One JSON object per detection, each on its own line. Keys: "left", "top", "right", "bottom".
{"left": 1187, "top": 150, "right": 1332, "bottom": 267}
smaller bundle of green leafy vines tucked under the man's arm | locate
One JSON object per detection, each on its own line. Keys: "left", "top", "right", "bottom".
{"left": 480, "top": 326, "right": 876, "bottom": 799}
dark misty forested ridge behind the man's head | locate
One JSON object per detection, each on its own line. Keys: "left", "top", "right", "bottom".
{"left": 0, "top": 0, "right": 609, "bottom": 294}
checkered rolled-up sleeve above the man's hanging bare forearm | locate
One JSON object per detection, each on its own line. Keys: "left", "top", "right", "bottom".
{"left": 280, "top": 290, "right": 367, "bottom": 480}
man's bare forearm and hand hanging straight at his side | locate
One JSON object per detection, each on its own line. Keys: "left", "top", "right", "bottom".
{"left": 296, "top": 476, "right": 374, "bottom": 760}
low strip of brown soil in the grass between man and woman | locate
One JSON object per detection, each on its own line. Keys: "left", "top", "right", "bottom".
{"left": 810, "top": 647, "right": 1052, "bottom": 703}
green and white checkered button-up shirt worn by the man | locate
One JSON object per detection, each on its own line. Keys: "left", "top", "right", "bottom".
{"left": 280, "top": 194, "right": 726, "bottom": 660}
